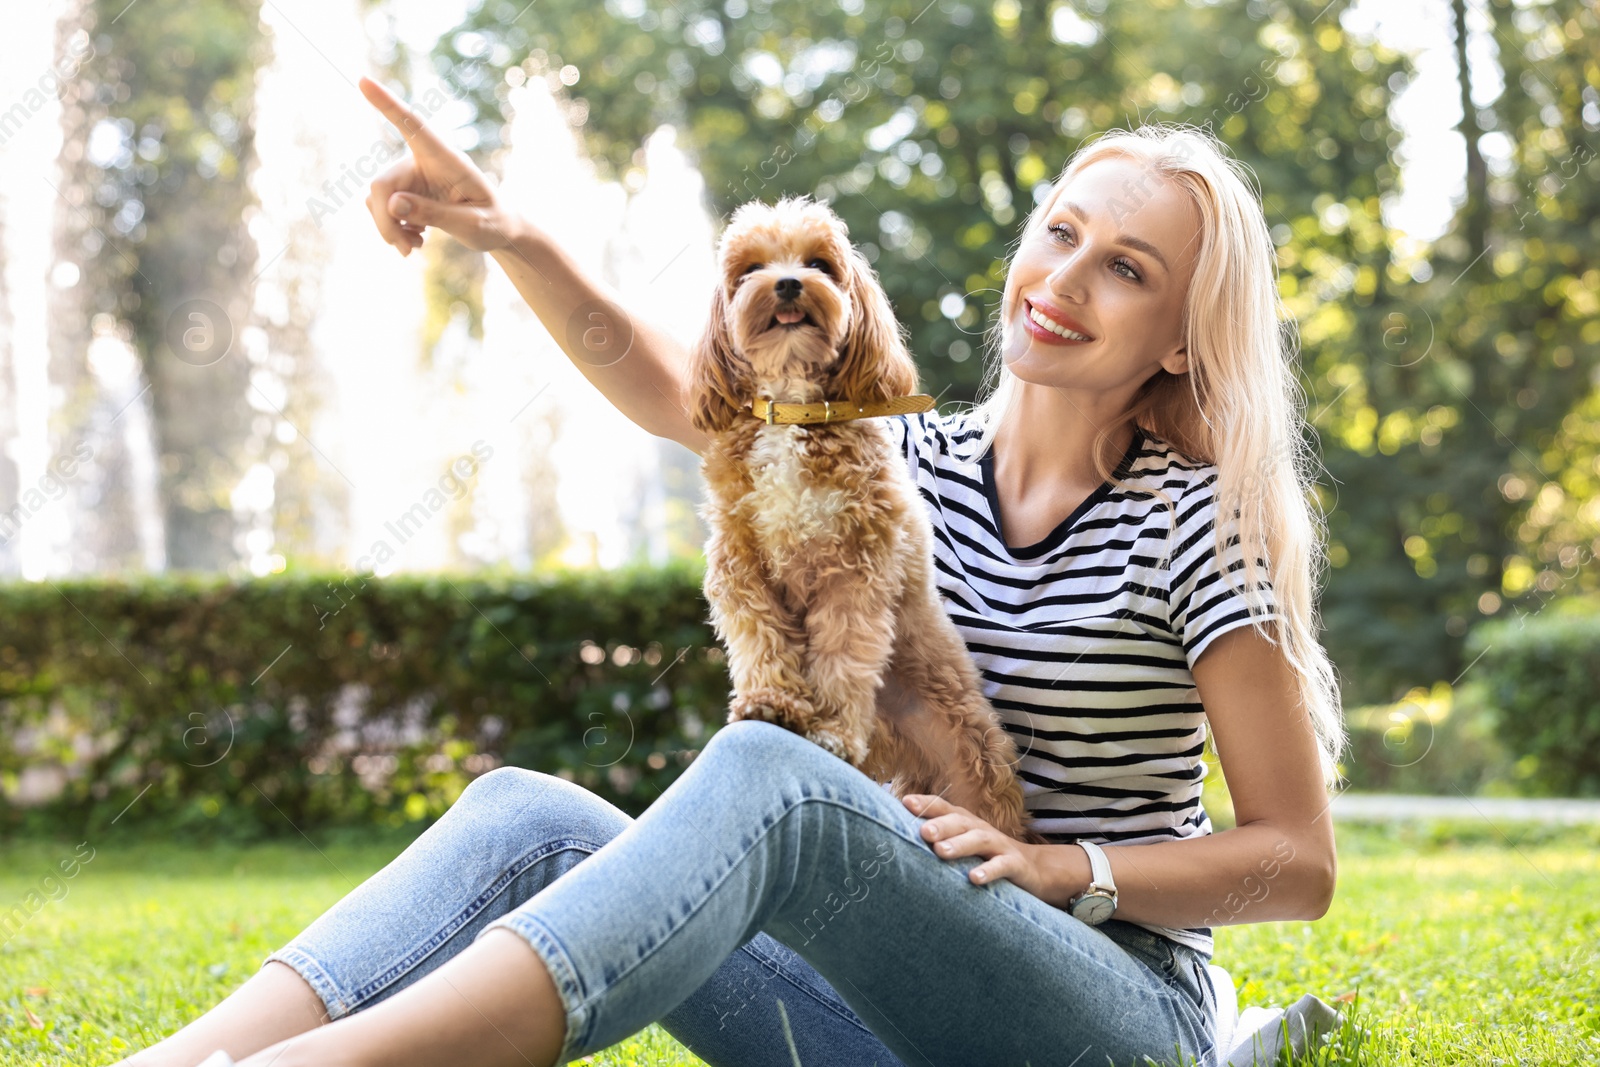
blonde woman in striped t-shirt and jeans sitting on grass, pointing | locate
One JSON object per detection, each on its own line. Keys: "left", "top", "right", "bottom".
{"left": 128, "top": 82, "right": 1342, "bottom": 1067}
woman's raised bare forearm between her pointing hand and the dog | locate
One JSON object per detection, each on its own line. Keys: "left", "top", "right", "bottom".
{"left": 491, "top": 219, "right": 707, "bottom": 453}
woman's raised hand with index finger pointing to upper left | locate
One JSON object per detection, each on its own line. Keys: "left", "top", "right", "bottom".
{"left": 360, "top": 78, "right": 520, "bottom": 256}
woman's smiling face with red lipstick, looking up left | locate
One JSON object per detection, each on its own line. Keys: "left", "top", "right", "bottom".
{"left": 1002, "top": 155, "right": 1200, "bottom": 398}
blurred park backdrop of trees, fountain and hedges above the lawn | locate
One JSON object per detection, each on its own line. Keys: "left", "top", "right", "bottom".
{"left": 0, "top": 0, "right": 1600, "bottom": 1062}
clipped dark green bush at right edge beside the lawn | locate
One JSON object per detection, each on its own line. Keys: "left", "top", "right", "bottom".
{"left": 1469, "top": 601, "right": 1600, "bottom": 797}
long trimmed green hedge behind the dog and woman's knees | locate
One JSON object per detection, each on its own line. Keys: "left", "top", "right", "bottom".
{"left": 0, "top": 565, "right": 728, "bottom": 832}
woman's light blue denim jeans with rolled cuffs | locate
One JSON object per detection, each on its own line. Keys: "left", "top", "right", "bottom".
{"left": 269, "top": 720, "right": 1219, "bottom": 1067}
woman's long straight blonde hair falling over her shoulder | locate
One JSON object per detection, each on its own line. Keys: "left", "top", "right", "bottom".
{"left": 971, "top": 123, "right": 1346, "bottom": 787}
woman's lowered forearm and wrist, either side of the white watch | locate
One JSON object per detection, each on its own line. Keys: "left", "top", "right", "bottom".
{"left": 1034, "top": 824, "right": 1336, "bottom": 929}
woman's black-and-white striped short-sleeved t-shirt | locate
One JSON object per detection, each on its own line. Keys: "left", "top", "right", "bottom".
{"left": 885, "top": 404, "right": 1277, "bottom": 955}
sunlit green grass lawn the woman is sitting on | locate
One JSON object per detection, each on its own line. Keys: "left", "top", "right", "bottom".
{"left": 0, "top": 824, "right": 1600, "bottom": 1067}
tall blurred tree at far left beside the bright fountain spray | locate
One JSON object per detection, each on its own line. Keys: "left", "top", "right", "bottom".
{"left": 53, "top": 0, "right": 266, "bottom": 569}
